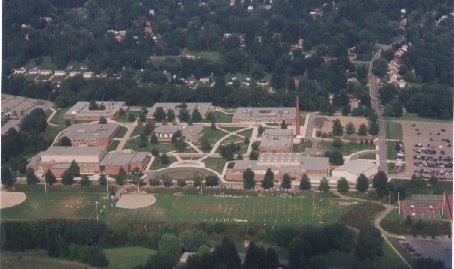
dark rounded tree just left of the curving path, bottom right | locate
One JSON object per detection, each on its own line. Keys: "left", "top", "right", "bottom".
{"left": 355, "top": 226, "right": 384, "bottom": 260}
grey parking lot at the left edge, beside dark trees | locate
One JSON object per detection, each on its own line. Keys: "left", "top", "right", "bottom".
{"left": 2, "top": 94, "right": 54, "bottom": 134}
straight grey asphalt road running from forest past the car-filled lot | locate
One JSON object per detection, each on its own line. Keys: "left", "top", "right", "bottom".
{"left": 368, "top": 52, "right": 388, "bottom": 174}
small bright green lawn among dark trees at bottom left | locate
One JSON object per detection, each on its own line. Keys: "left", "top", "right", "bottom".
{"left": 104, "top": 247, "right": 156, "bottom": 269}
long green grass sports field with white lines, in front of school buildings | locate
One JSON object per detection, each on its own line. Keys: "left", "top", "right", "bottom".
{"left": 0, "top": 187, "right": 354, "bottom": 227}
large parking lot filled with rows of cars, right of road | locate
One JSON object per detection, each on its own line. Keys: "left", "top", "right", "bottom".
{"left": 400, "top": 121, "right": 453, "bottom": 180}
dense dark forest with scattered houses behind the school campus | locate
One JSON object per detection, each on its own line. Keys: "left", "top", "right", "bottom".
{"left": 2, "top": 0, "right": 454, "bottom": 118}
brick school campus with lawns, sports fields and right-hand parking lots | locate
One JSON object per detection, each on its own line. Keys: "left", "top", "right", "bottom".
{"left": 1, "top": 95, "right": 452, "bottom": 268}
